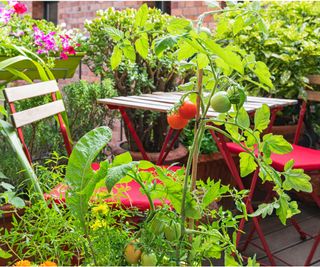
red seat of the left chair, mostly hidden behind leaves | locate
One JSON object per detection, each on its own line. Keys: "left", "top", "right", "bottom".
{"left": 45, "top": 163, "right": 181, "bottom": 211}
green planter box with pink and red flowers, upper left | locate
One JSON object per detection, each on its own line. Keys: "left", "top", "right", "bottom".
{"left": 0, "top": 1, "right": 84, "bottom": 81}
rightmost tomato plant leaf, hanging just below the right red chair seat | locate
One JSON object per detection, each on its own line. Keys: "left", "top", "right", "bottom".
{"left": 283, "top": 169, "right": 312, "bottom": 193}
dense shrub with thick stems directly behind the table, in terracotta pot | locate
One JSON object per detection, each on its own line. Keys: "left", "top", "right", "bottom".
{"left": 84, "top": 4, "right": 190, "bottom": 152}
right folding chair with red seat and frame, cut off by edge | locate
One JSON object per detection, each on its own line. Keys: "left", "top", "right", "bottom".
{"left": 226, "top": 77, "right": 320, "bottom": 266}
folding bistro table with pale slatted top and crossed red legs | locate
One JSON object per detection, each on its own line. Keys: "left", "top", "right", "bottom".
{"left": 98, "top": 92, "right": 299, "bottom": 265}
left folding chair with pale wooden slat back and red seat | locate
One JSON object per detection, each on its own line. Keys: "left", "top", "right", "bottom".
{"left": 4, "top": 80, "right": 179, "bottom": 213}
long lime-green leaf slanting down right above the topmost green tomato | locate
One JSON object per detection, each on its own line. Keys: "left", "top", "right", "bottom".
{"left": 205, "top": 41, "right": 244, "bottom": 74}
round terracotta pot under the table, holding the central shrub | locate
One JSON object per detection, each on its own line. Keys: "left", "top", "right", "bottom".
{"left": 110, "top": 141, "right": 188, "bottom": 165}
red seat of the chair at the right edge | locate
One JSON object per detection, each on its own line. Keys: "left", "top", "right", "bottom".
{"left": 227, "top": 142, "right": 320, "bottom": 171}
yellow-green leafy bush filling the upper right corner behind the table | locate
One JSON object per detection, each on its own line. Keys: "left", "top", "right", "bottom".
{"left": 215, "top": 1, "right": 320, "bottom": 98}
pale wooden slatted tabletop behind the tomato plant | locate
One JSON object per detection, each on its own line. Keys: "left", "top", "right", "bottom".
{"left": 98, "top": 92, "right": 297, "bottom": 117}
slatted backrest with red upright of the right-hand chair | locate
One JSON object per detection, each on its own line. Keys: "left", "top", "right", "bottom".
{"left": 293, "top": 75, "right": 320, "bottom": 145}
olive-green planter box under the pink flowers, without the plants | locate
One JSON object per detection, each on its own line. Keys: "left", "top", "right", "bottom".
{"left": 0, "top": 53, "right": 84, "bottom": 81}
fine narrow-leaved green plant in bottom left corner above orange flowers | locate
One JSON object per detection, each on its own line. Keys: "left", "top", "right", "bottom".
{"left": 1, "top": 202, "right": 85, "bottom": 266}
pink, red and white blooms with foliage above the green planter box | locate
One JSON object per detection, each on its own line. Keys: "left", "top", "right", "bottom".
{"left": 0, "top": 1, "right": 81, "bottom": 66}
